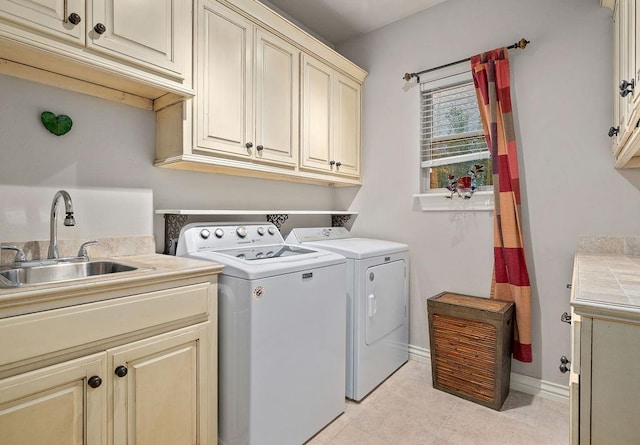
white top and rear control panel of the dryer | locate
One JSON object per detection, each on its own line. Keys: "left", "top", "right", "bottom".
{"left": 286, "top": 227, "right": 409, "bottom": 260}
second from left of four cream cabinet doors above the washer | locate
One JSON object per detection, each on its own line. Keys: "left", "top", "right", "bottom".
{"left": 255, "top": 29, "right": 300, "bottom": 165}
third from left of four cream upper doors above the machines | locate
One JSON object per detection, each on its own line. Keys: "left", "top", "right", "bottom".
{"left": 300, "top": 54, "right": 336, "bottom": 171}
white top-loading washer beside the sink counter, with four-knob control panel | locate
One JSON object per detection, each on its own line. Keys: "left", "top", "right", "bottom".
{"left": 176, "top": 223, "right": 346, "bottom": 445}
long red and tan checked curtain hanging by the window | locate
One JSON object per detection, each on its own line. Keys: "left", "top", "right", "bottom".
{"left": 471, "top": 48, "right": 533, "bottom": 362}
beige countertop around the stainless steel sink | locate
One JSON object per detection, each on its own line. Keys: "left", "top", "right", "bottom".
{"left": 0, "top": 253, "right": 223, "bottom": 318}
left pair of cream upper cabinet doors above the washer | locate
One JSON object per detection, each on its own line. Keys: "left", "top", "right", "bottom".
{"left": 196, "top": 1, "right": 300, "bottom": 165}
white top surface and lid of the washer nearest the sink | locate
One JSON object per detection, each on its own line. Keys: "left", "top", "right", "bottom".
{"left": 185, "top": 244, "right": 346, "bottom": 280}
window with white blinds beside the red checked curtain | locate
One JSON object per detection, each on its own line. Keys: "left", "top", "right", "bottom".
{"left": 418, "top": 62, "right": 493, "bottom": 210}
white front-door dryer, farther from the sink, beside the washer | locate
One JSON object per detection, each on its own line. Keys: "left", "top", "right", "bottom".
{"left": 286, "top": 227, "right": 409, "bottom": 401}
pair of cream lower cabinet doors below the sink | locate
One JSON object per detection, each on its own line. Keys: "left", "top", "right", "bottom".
{"left": 0, "top": 322, "right": 215, "bottom": 445}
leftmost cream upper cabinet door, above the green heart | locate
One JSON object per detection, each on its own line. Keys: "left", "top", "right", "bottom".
{"left": 0, "top": 0, "right": 86, "bottom": 45}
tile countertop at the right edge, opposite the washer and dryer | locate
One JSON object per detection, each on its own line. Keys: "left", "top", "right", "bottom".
{"left": 570, "top": 252, "right": 640, "bottom": 323}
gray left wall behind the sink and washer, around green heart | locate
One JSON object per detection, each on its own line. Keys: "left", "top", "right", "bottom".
{"left": 0, "top": 75, "right": 333, "bottom": 245}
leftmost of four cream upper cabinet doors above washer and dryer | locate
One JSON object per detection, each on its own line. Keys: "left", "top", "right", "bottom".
{"left": 194, "top": 0, "right": 255, "bottom": 159}
